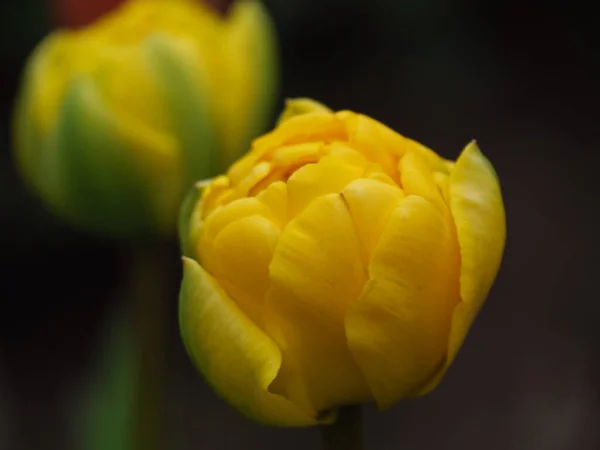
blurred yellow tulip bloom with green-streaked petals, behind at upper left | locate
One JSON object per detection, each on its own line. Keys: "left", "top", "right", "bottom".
{"left": 14, "top": 0, "right": 277, "bottom": 236}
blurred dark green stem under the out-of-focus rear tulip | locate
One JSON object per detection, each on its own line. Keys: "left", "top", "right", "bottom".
{"left": 131, "top": 247, "right": 169, "bottom": 450}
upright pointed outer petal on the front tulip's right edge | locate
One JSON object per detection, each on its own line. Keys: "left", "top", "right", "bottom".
{"left": 410, "top": 142, "right": 506, "bottom": 395}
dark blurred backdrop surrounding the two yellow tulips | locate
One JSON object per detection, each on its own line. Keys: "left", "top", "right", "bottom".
{"left": 0, "top": 0, "right": 600, "bottom": 450}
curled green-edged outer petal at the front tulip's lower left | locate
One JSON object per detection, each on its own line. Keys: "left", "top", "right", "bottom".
{"left": 179, "top": 258, "right": 317, "bottom": 426}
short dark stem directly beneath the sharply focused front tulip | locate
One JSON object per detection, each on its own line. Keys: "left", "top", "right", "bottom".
{"left": 320, "top": 405, "right": 363, "bottom": 450}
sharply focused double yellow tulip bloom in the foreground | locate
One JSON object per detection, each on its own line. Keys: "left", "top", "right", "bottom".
{"left": 180, "top": 100, "right": 505, "bottom": 426}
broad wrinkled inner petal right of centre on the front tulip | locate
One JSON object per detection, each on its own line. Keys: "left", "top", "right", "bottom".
{"left": 346, "top": 196, "right": 458, "bottom": 408}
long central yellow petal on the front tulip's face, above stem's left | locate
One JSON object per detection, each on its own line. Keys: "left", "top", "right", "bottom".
{"left": 267, "top": 193, "right": 372, "bottom": 412}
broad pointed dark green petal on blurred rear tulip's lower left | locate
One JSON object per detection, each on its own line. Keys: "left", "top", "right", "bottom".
{"left": 46, "top": 77, "right": 162, "bottom": 236}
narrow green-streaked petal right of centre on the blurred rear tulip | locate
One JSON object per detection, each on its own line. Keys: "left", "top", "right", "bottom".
{"left": 144, "top": 34, "right": 220, "bottom": 188}
